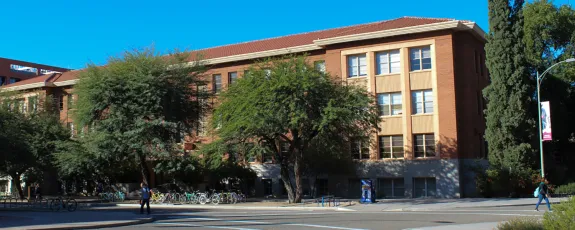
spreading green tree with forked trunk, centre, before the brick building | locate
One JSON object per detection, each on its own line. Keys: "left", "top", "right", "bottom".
{"left": 212, "top": 56, "right": 379, "bottom": 202}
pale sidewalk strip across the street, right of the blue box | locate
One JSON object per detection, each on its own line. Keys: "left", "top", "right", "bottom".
{"left": 349, "top": 198, "right": 568, "bottom": 211}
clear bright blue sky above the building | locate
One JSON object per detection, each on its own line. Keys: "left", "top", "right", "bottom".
{"left": 0, "top": 0, "right": 568, "bottom": 69}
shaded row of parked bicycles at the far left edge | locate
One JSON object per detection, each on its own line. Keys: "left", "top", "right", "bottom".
{"left": 0, "top": 197, "right": 78, "bottom": 212}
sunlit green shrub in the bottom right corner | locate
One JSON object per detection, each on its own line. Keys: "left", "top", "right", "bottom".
{"left": 543, "top": 197, "right": 575, "bottom": 230}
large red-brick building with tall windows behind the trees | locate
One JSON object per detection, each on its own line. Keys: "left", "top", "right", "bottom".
{"left": 4, "top": 17, "right": 489, "bottom": 198}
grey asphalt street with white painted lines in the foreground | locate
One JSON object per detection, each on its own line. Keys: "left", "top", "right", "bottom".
{"left": 101, "top": 206, "right": 544, "bottom": 230}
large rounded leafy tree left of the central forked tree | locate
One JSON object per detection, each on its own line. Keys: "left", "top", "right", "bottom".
{"left": 74, "top": 48, "right": 206, "bottom": 182}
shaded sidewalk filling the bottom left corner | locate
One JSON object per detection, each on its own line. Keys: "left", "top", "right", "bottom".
{"left": 0, "top": 211, "right": 154, "bottom": 229}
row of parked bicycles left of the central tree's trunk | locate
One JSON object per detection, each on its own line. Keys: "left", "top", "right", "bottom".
{"left": 151, "top": 190, "right": 247, "bottom": 204}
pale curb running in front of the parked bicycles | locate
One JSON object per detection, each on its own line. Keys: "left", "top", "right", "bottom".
{"left": 116, "top": 204, "right": 356, "bottom": 212}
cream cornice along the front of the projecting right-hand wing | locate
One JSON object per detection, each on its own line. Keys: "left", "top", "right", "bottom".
{"left": 313, "top": 21, "right": 459, "bottom": 46}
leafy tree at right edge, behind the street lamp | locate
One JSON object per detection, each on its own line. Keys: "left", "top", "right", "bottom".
{"left": 523, "top": 0, "right": 575, "bottom": 184}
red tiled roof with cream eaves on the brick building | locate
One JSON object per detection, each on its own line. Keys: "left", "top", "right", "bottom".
{"left": 1, "top": 17, "right": 485, "bottom": 90}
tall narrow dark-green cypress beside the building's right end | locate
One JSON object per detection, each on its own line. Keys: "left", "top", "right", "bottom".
{"left": 484, "top": 0, "right": 536, "bottom": 195}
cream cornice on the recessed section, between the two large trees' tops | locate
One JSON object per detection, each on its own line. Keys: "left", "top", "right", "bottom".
{"left": 201, "top": 44, "right": 322, "bottom": 64}
